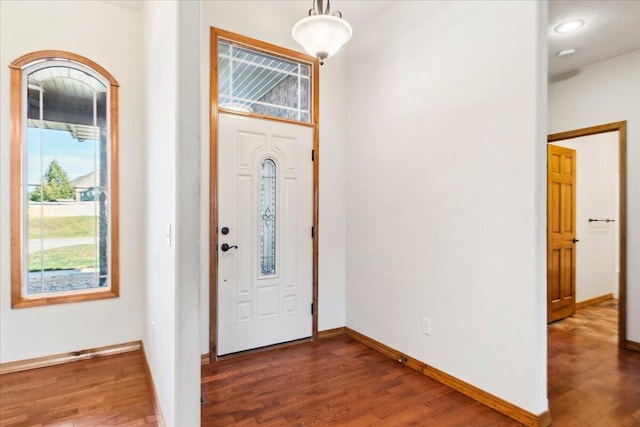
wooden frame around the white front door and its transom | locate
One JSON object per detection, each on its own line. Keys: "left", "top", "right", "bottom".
{"left": 208, "top": 27, "right": 320, "bottom": 361}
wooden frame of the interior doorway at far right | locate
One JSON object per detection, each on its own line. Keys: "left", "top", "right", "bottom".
{"left": 547, "top": 120, "right": 640, "bottom": 351}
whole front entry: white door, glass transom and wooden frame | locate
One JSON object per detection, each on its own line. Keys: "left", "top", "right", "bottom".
{"left": 209, "top": 27, "right": 319, "bottom": 360}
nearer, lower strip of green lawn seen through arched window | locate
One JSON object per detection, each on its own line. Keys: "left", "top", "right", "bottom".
{"left": 29, "top": 245, "right": 97, "bottom": 271}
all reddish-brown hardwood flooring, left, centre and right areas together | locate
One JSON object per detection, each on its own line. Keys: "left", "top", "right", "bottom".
{"left": 0, "top": 302, "right": 640, "bottom": 427}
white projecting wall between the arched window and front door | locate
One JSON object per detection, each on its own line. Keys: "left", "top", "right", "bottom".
{"left": 143, "top": 1, "right": 200, "bottom": 426}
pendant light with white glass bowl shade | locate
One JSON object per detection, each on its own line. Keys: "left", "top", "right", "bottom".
{"left": 291, "top": 0, "right": 352, "bottom": 65}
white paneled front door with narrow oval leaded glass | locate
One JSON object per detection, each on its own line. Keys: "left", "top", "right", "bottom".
{"left": 217, "top": 113, "right": 313, "bottom": 356}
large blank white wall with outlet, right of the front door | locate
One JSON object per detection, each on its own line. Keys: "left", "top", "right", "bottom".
{"left": 346, "top": 1, "right": 547, "bottom": 414}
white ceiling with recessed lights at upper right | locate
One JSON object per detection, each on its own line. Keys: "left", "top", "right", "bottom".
{"left": 547, "top": 0, "right": 640, "bottom": 77}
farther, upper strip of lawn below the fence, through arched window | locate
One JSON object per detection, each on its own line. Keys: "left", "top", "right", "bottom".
{"left": 29, "top": 216, "right": 98, "bottom": 239}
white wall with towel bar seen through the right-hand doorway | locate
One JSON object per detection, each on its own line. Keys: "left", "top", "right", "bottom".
{"left": 554, "top": 132, "right": 620, "bottom": 302}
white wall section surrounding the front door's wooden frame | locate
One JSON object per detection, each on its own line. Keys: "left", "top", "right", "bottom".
{"left": 200, "top": 1, "right": 346, "bottom": 353}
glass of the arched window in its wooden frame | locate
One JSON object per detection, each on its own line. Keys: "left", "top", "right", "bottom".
{"left": 25, "top": 66, "right": 109, "bottom": 295}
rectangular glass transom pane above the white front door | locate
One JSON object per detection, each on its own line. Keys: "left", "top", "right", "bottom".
{"left": 218, "top": 41, "right": 311, "bottom": 123}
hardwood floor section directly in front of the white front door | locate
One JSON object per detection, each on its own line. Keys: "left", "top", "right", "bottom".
{"left": 202, "top": 336, "right": 519, "bottom": 426}
